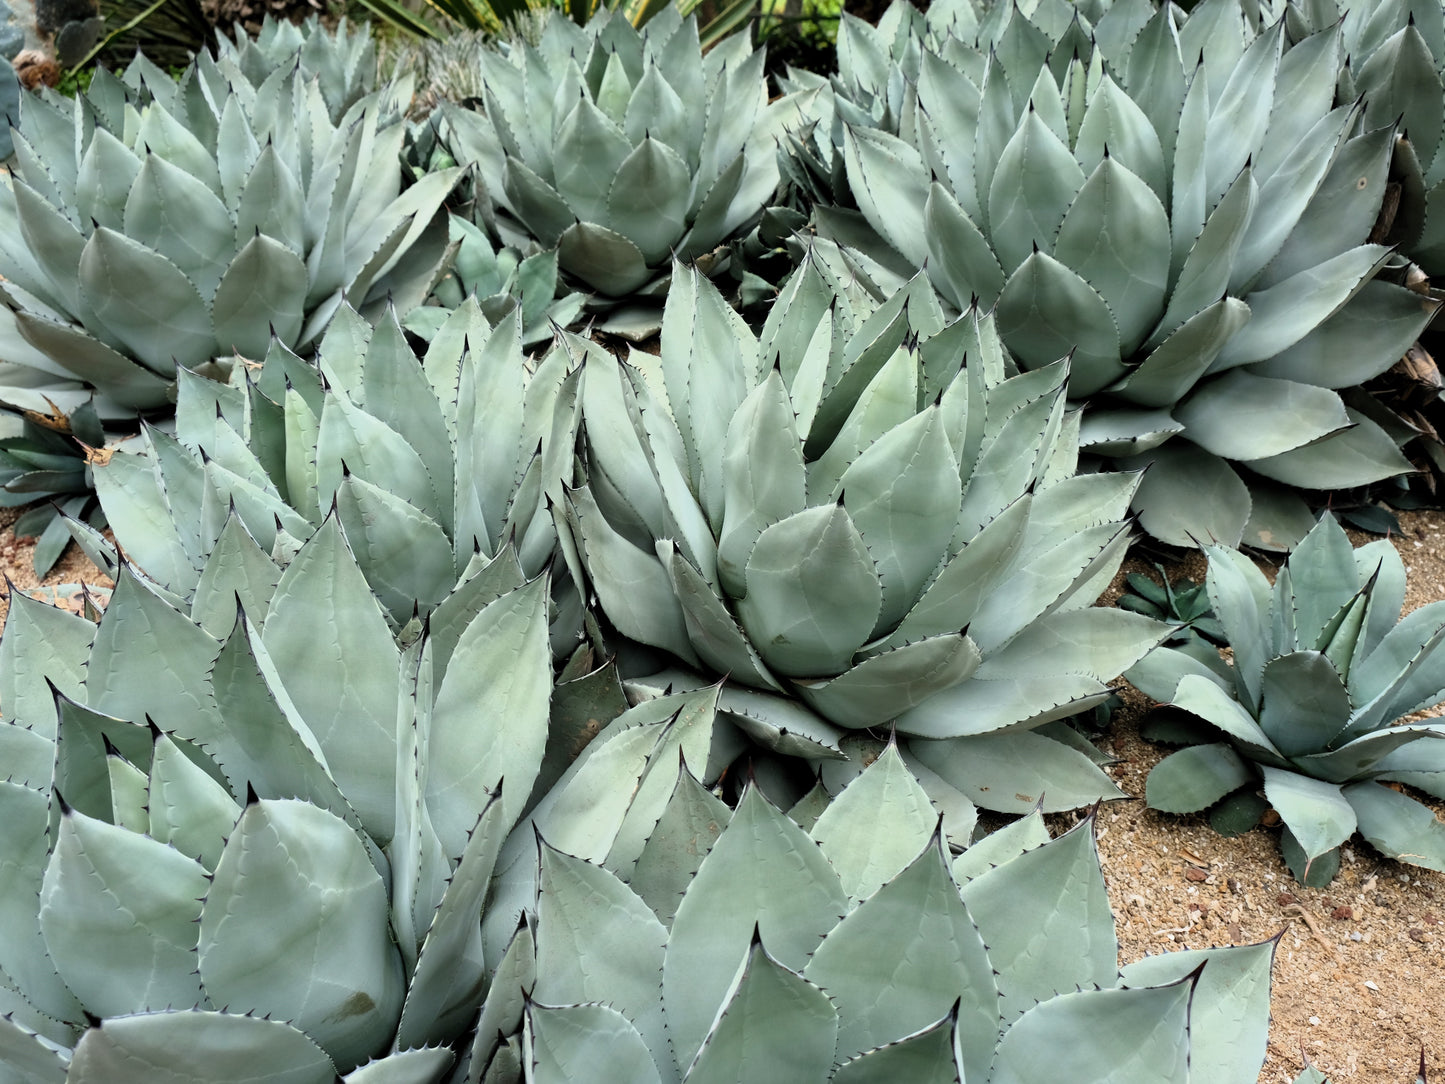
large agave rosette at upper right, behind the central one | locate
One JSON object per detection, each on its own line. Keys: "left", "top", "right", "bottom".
{"left": 797, "top": 3, "right": 1435, "bottom": 548}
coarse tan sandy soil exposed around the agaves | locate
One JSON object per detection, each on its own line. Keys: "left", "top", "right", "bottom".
{"left": 0, "top": 510, "right": 1445, "bottom": 1084}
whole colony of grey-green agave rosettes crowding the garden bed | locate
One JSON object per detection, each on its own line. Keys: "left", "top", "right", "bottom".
{"left": 0, "top": 0, "right": 1445, "bottom": 1084}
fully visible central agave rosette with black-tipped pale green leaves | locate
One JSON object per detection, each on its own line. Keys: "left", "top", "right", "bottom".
{"left": 557, "top": 252, "right": 1168, "bottom": 812}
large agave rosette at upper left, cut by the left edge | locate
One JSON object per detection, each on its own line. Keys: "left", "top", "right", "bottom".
{"left": 0, "top": 46, "right": 461, "bottom": 419}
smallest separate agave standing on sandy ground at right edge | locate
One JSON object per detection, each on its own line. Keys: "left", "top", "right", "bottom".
{"left": 1127, "top": 516, "right": 1445, "bottom": 885}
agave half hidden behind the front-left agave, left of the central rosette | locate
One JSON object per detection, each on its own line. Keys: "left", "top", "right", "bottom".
{"left": 71, "top": 301, "right": 581, "bottom": 655}
